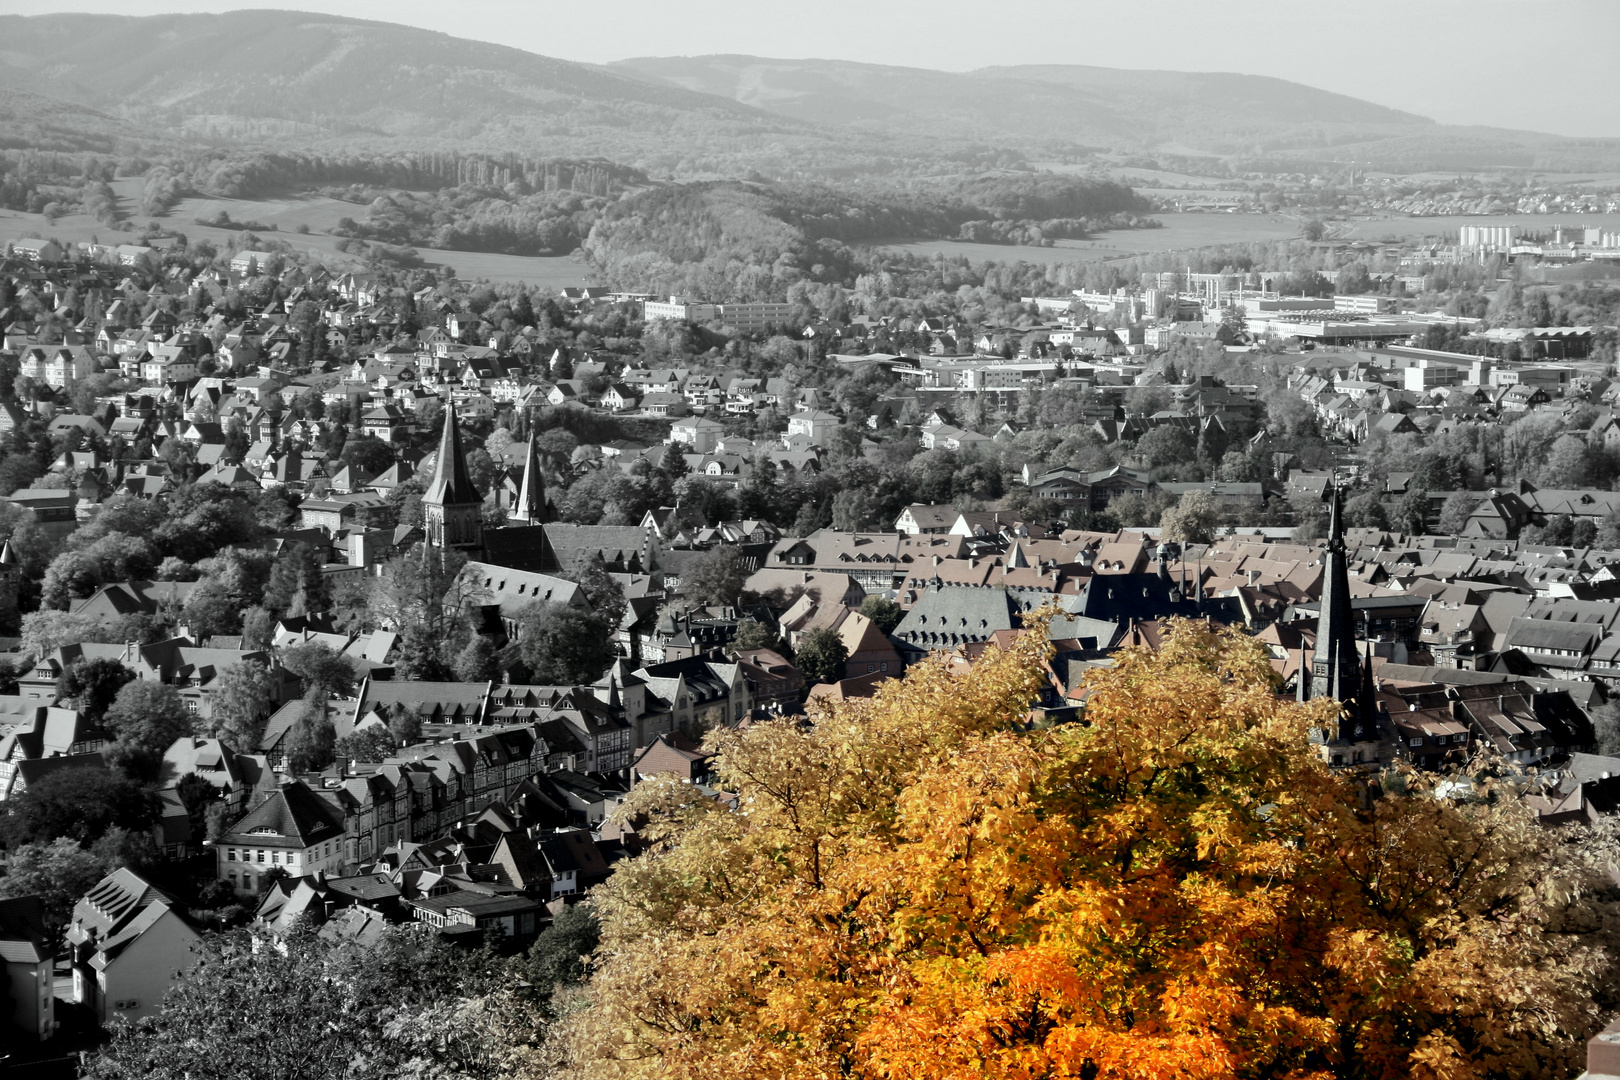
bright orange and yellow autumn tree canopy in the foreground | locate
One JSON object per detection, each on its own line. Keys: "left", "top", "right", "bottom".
{"left": 569, "top": 622, "right": 1620, "bottom": 1080}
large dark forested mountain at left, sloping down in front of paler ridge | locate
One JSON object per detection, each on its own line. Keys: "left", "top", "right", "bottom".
{"left": 0, "top": 10, "right": 822, "bottom": 170}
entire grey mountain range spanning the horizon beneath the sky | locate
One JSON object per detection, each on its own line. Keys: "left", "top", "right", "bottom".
{"left": 0, "top": 10, "right": 1620, "bottom": 178}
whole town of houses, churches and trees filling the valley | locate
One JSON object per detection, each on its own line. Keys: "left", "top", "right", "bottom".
{"left": 0, "top": 232, "right": 1620, "bottom": 1041}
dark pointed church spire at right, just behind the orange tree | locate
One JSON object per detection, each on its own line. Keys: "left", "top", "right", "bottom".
{"left": 1299, "top": 484, "right": 1382, "bottom": 764}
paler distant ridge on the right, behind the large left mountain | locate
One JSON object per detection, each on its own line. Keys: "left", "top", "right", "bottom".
{"left": 608, "top": 55, "right": 1620, "bottom": 168}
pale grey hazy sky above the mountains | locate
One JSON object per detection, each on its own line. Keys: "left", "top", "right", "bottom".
{"left": 9, "top": 0, "right": 1620, "bottom": 136}
